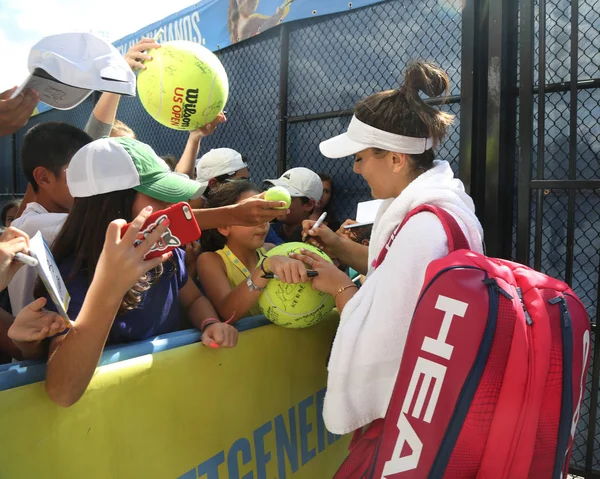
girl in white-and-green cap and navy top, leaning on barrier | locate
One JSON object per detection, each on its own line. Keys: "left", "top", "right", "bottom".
{"left": 36, "top": 137, "right": 237, "bottom": 406}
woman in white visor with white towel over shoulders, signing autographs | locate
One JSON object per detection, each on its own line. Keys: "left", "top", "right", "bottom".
{"left": 294, "top": 62, "right": 483, "bottom": 446}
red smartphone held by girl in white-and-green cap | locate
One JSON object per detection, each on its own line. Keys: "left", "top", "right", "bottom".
{"left": 121, "top": 202, "right": 201, "bottom": 260}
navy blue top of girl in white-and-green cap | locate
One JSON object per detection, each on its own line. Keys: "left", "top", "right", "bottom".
{"left": 46, "top": 248, "right": 188, "bottom": 344}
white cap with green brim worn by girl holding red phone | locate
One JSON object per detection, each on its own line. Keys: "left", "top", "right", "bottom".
{"left": 67, "top": 137, "right": 204, "bottom": 203}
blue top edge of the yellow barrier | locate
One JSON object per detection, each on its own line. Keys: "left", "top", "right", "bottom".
{"left": 0, "top": 316, "right": 271, "bottom": 391}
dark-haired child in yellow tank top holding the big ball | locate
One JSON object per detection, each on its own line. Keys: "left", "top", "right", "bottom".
{"left": 197, "top": 180, "right": 308, "bottom": 322}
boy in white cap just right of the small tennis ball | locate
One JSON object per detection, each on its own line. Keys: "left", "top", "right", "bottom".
{"left": 265, "top": 167, "right": 323, "bottom": 243}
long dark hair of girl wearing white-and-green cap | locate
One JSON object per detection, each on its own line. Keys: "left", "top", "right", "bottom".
{"left": 35, "top": 189, "right": 163, "bottom": 314}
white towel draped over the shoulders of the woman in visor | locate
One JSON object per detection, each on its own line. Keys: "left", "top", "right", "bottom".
{"left": 323, "top": 161, "right": 483, "bottom": 434}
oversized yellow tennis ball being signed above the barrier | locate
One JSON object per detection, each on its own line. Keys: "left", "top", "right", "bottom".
{"left": 258, "top": 243, "right": 335, "bottom": 328}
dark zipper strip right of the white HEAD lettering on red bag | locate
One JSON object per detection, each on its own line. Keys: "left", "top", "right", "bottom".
{"left": 428, "top": 274, "right": 500, "bottom": 479}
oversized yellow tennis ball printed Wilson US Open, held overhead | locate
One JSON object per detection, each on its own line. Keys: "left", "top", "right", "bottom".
{"left": 137, "top": 40, "right": 229, "bottom": 130}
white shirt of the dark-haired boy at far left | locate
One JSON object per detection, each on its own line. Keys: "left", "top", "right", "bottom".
{"left": 8, "top": 202, "right": 67, "bottom": 316}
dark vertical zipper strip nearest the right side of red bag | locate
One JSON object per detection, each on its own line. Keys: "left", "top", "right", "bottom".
{"left": 548, "top": 296, "right": 573, "bottom": 479}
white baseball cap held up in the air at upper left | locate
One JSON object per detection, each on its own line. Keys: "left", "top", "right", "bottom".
{"left": 13, "top": 33, "right": 135, "bottom": 110}
